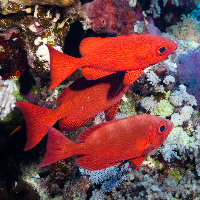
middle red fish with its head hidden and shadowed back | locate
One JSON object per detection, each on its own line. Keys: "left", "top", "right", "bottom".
{"left": 16, "top": 73, "right": 129, "bottom": 150}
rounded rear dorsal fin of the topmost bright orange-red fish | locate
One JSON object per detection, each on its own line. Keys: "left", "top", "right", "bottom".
{"left": 79, "top": 37, "right": 109, "bottom": 56}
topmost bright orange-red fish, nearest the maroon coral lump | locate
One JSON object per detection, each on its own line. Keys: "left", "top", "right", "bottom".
{"left": 48, "top": 34, "right": 177, "bottom": 89}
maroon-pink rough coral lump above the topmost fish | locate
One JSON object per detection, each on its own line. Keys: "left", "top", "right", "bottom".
{"left": 84, "top": 0, "right": 136, "bottom": 35}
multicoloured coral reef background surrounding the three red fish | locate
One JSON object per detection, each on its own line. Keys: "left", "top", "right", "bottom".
{"left": 0, "top": 0, "right": 200, "bottom": 200}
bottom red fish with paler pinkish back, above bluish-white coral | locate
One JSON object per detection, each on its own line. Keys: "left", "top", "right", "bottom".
{"left": 37, "top": 114, "right": 173, "bottom": 171}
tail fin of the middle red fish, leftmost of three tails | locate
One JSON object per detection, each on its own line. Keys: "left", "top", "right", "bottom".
{"left": 15, "top": 102, "right": 55, "bottom": 151}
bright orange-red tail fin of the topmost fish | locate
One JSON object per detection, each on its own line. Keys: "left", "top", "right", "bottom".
{"left": 47, "top": 45, "right": 80, "bottom": 89}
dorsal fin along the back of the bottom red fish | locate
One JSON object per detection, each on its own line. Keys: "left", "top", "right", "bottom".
{"left": 76, "top": 123, "right": 108, "bottom": 143}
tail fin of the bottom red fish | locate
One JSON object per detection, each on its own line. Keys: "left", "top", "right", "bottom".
{"left": 37, "top": 126, "right": 77, "bottom": 168}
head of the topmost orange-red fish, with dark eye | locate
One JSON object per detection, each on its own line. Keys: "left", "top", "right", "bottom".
{"left": 146, "top": 36, "right": 177, "bottom": 65}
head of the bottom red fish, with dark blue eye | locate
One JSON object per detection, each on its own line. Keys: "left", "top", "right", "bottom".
{"left": 149, "top": 116, "right": 173, "bottom": 147}
